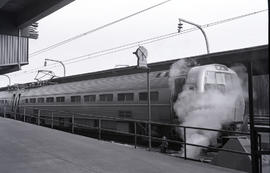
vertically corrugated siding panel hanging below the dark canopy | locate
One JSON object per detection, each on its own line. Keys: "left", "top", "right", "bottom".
{"left": 0, "top": 35, "right": 28, "bottom": 66}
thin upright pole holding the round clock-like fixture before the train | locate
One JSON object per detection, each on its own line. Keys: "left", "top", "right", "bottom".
{"left": 147, "top": 67, "right": 152, "bottom": 151}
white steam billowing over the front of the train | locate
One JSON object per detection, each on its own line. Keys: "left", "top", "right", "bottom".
{"left": 169, "top": 60, "right": 245, "bottom": 158}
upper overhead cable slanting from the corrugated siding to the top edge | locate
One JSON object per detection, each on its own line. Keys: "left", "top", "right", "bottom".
{"left": 30, "top": 0, "right": 171, "bottom": 57}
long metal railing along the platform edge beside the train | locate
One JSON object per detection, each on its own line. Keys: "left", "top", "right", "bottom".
{"left": 0, "top": 106, "right": 267, "bottom": 170}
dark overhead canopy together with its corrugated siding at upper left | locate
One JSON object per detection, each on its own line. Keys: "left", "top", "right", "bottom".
{"left": 0, "top": 0, "right": 74, "bottom": 75}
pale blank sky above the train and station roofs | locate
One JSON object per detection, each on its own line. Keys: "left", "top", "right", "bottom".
{"left": 0, "top": 0, "right": 268, "bottom": 87}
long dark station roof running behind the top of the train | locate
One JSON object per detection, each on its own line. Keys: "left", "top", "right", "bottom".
{"left": 0, "top": 45, "right": 269, "bottom": 91}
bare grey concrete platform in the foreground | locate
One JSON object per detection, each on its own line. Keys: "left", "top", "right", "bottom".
{"left": 0, "top": 118, "right": 245, "bottom": 173}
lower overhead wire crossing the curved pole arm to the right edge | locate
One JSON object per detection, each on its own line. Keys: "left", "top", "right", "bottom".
{"left": 8, "top": 9, "right": 268, "bottom": 75}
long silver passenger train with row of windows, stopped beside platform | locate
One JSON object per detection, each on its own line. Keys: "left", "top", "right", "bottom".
{"left": 0, "top": 60, "right": 247, "bottom": 139}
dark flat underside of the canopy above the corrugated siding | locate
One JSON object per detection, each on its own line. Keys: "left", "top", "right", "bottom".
{"left": 0, "top": 0, "right": 74, "bottom": 35}
